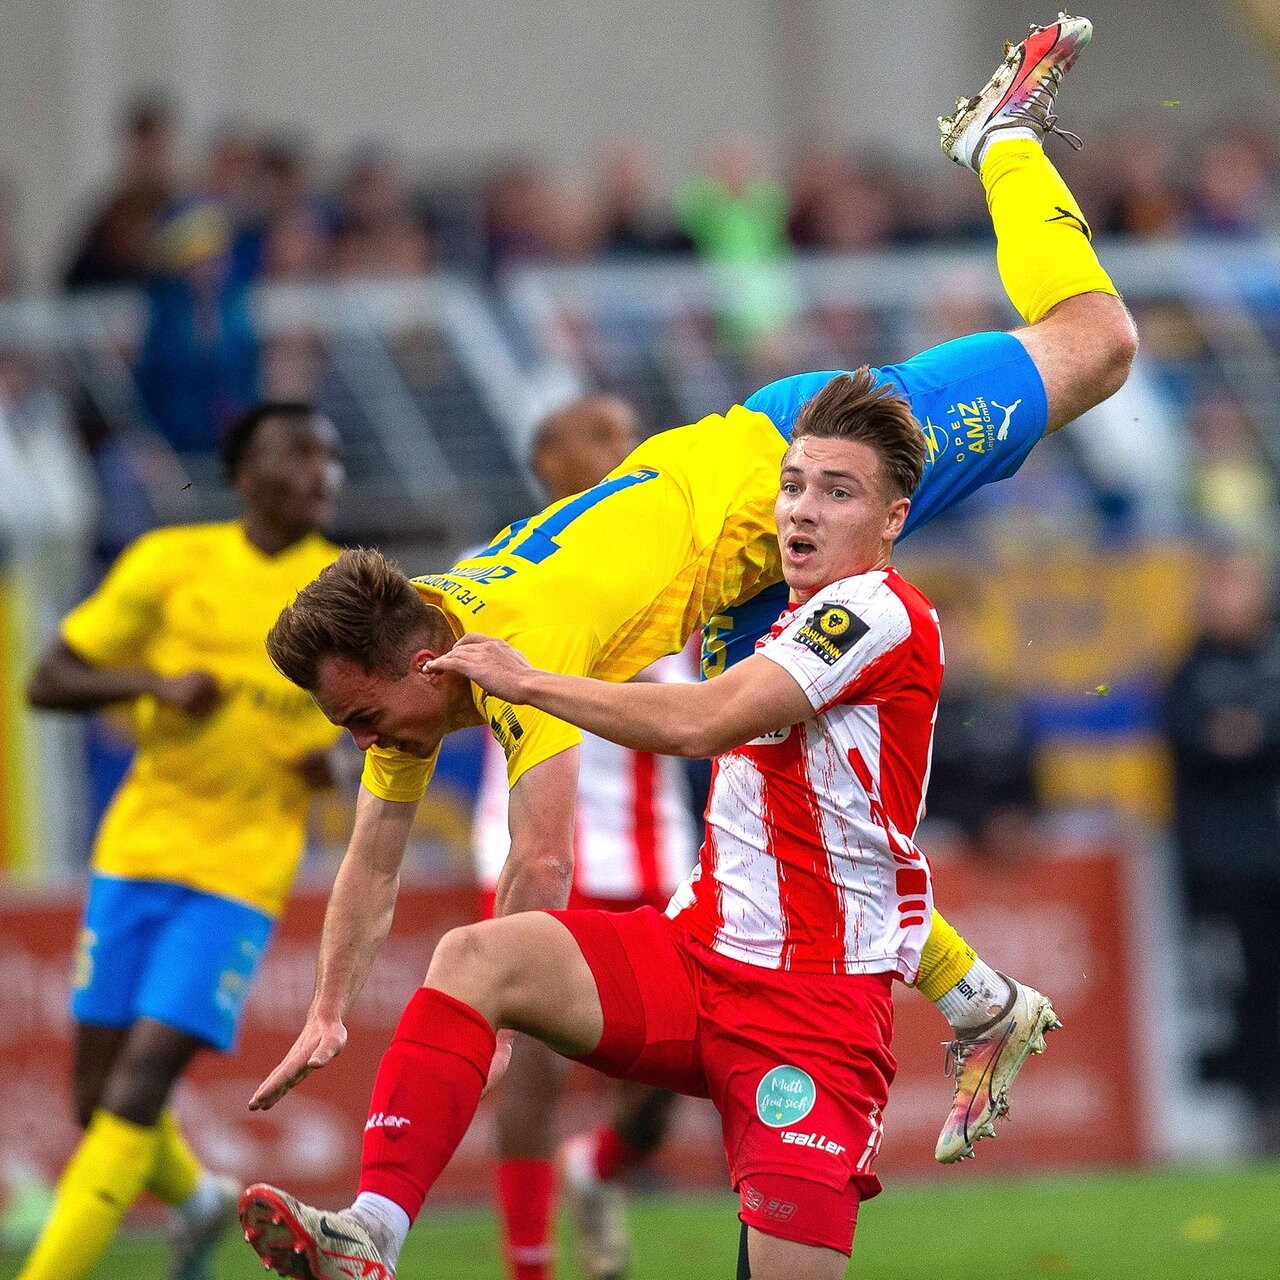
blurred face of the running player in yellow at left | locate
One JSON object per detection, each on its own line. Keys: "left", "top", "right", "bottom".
{"left": 239, "top": 413, "right": 347, "bottom": 535}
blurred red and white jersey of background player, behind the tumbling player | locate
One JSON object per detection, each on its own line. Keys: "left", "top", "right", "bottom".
{"left": 471, "top": 653, "right": 698, "bottom": 901}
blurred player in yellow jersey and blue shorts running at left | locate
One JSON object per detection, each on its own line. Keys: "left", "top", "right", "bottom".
{"left": 20, "top": 402, "right": 344, "bottom": 1280}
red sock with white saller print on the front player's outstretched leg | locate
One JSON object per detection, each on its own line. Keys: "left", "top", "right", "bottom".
{"left": 360, "top": 987, "right": 495, "bottom": 1219}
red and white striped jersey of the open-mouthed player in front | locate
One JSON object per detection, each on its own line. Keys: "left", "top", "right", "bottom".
{"left": 667, "top": 568, "right": 942, "bottom": 980}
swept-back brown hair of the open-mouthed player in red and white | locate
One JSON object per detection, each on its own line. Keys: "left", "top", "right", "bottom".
{"left": 791, "top": 365, "right": 924, "bottom": 498}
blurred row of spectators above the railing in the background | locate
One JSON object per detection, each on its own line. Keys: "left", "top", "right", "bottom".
{"left": 0, "top": 96, "right": 1280, "bottom": 304}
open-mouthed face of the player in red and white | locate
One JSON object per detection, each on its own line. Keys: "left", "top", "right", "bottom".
{"left": 774, "top": 435, "right": 911, "bottom": 604}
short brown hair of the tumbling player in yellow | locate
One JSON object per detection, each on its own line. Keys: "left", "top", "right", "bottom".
{"left": 266, "top": 547, "right": 448, "bottom": 691}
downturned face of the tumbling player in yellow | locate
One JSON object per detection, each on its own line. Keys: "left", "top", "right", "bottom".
{"left": 312, "top": 654, "right": 465, "bottom": 759}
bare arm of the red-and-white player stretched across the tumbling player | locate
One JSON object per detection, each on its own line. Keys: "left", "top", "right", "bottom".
{"left": 431, "top": 635, "right": 813, "bottom": 757}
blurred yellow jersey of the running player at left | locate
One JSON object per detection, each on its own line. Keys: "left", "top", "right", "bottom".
{"left": 61, "top": 522, "right": 340, "bottom": 915}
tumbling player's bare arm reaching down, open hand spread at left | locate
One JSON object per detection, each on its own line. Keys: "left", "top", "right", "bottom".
{"left": 250, "top": 787, "right": 417, "bottom": 1111}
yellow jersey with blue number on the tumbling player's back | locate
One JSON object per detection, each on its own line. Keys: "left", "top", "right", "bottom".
{"left": 362, "top": 404, "right": 787, "bottom": 800}
